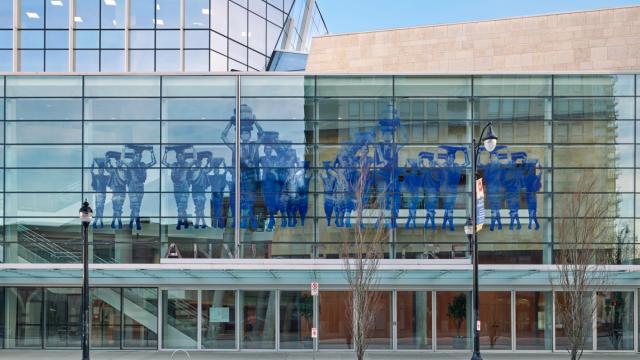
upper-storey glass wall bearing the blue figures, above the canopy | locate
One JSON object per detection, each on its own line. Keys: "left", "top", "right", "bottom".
{"left": 0, "top": 75, "right": 640, "bottom": 264}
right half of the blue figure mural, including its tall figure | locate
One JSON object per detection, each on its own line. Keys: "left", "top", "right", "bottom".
{"left": 319, "top": 105, "right": 541, "bottom": 231}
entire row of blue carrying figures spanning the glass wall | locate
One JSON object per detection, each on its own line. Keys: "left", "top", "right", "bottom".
{"left": 91, "top": 104, "right": 541, "bottom": 231}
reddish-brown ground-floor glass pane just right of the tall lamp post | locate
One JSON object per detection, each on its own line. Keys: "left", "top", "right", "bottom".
{"left": 480, "top": 291, "right": 511, "bottom": 350}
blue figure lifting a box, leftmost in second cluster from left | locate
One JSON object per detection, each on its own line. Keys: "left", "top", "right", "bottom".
{"left": 162, "top": 145, "right": 193, "bottom": 230}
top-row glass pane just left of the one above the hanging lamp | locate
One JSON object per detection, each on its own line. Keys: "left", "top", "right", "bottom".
{"left": 394, "top": 76, "right": 471, "bottom": 97}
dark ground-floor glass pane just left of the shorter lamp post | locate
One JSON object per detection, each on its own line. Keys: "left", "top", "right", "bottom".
{"left": 45, "top": 288, "right": 82, "bottom": 348}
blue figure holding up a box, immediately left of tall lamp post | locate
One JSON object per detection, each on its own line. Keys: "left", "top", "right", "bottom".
{"left": 438, "top": 145, "right": 469, "bottom": 231}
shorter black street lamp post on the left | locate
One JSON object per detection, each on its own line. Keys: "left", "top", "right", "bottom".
{"left": 79, "top": 199, "right": 93, "bottom": 360}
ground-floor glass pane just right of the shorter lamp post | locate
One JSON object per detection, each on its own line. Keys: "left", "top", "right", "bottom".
{"left": 90, "top": 288, "right": 122, "bottom": 349}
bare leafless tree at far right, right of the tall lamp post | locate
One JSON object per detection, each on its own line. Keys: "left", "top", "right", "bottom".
{"left": 550, "top": 177, "right": 614, "bottom": 360}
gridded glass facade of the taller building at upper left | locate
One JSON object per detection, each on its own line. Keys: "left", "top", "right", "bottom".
{"left": 0, "top": 0, "right": 327, "bottom": 73}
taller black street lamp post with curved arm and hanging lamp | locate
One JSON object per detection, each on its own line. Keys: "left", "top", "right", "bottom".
{"left": 464, "top": 123, "right": 498, "bottom": 360}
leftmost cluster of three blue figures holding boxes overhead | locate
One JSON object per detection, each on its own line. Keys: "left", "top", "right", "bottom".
{"left": 91, "top": 144, "right": 156, "bottom": 230}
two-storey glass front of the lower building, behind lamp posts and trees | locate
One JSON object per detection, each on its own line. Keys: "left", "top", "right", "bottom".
{"left": 0, "top": 73, "right": 640, "bottom": 351}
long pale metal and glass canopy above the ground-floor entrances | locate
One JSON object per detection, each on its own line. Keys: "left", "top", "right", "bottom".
{"left": 0, "top": 259, "right": 640, "bottom": 289}
